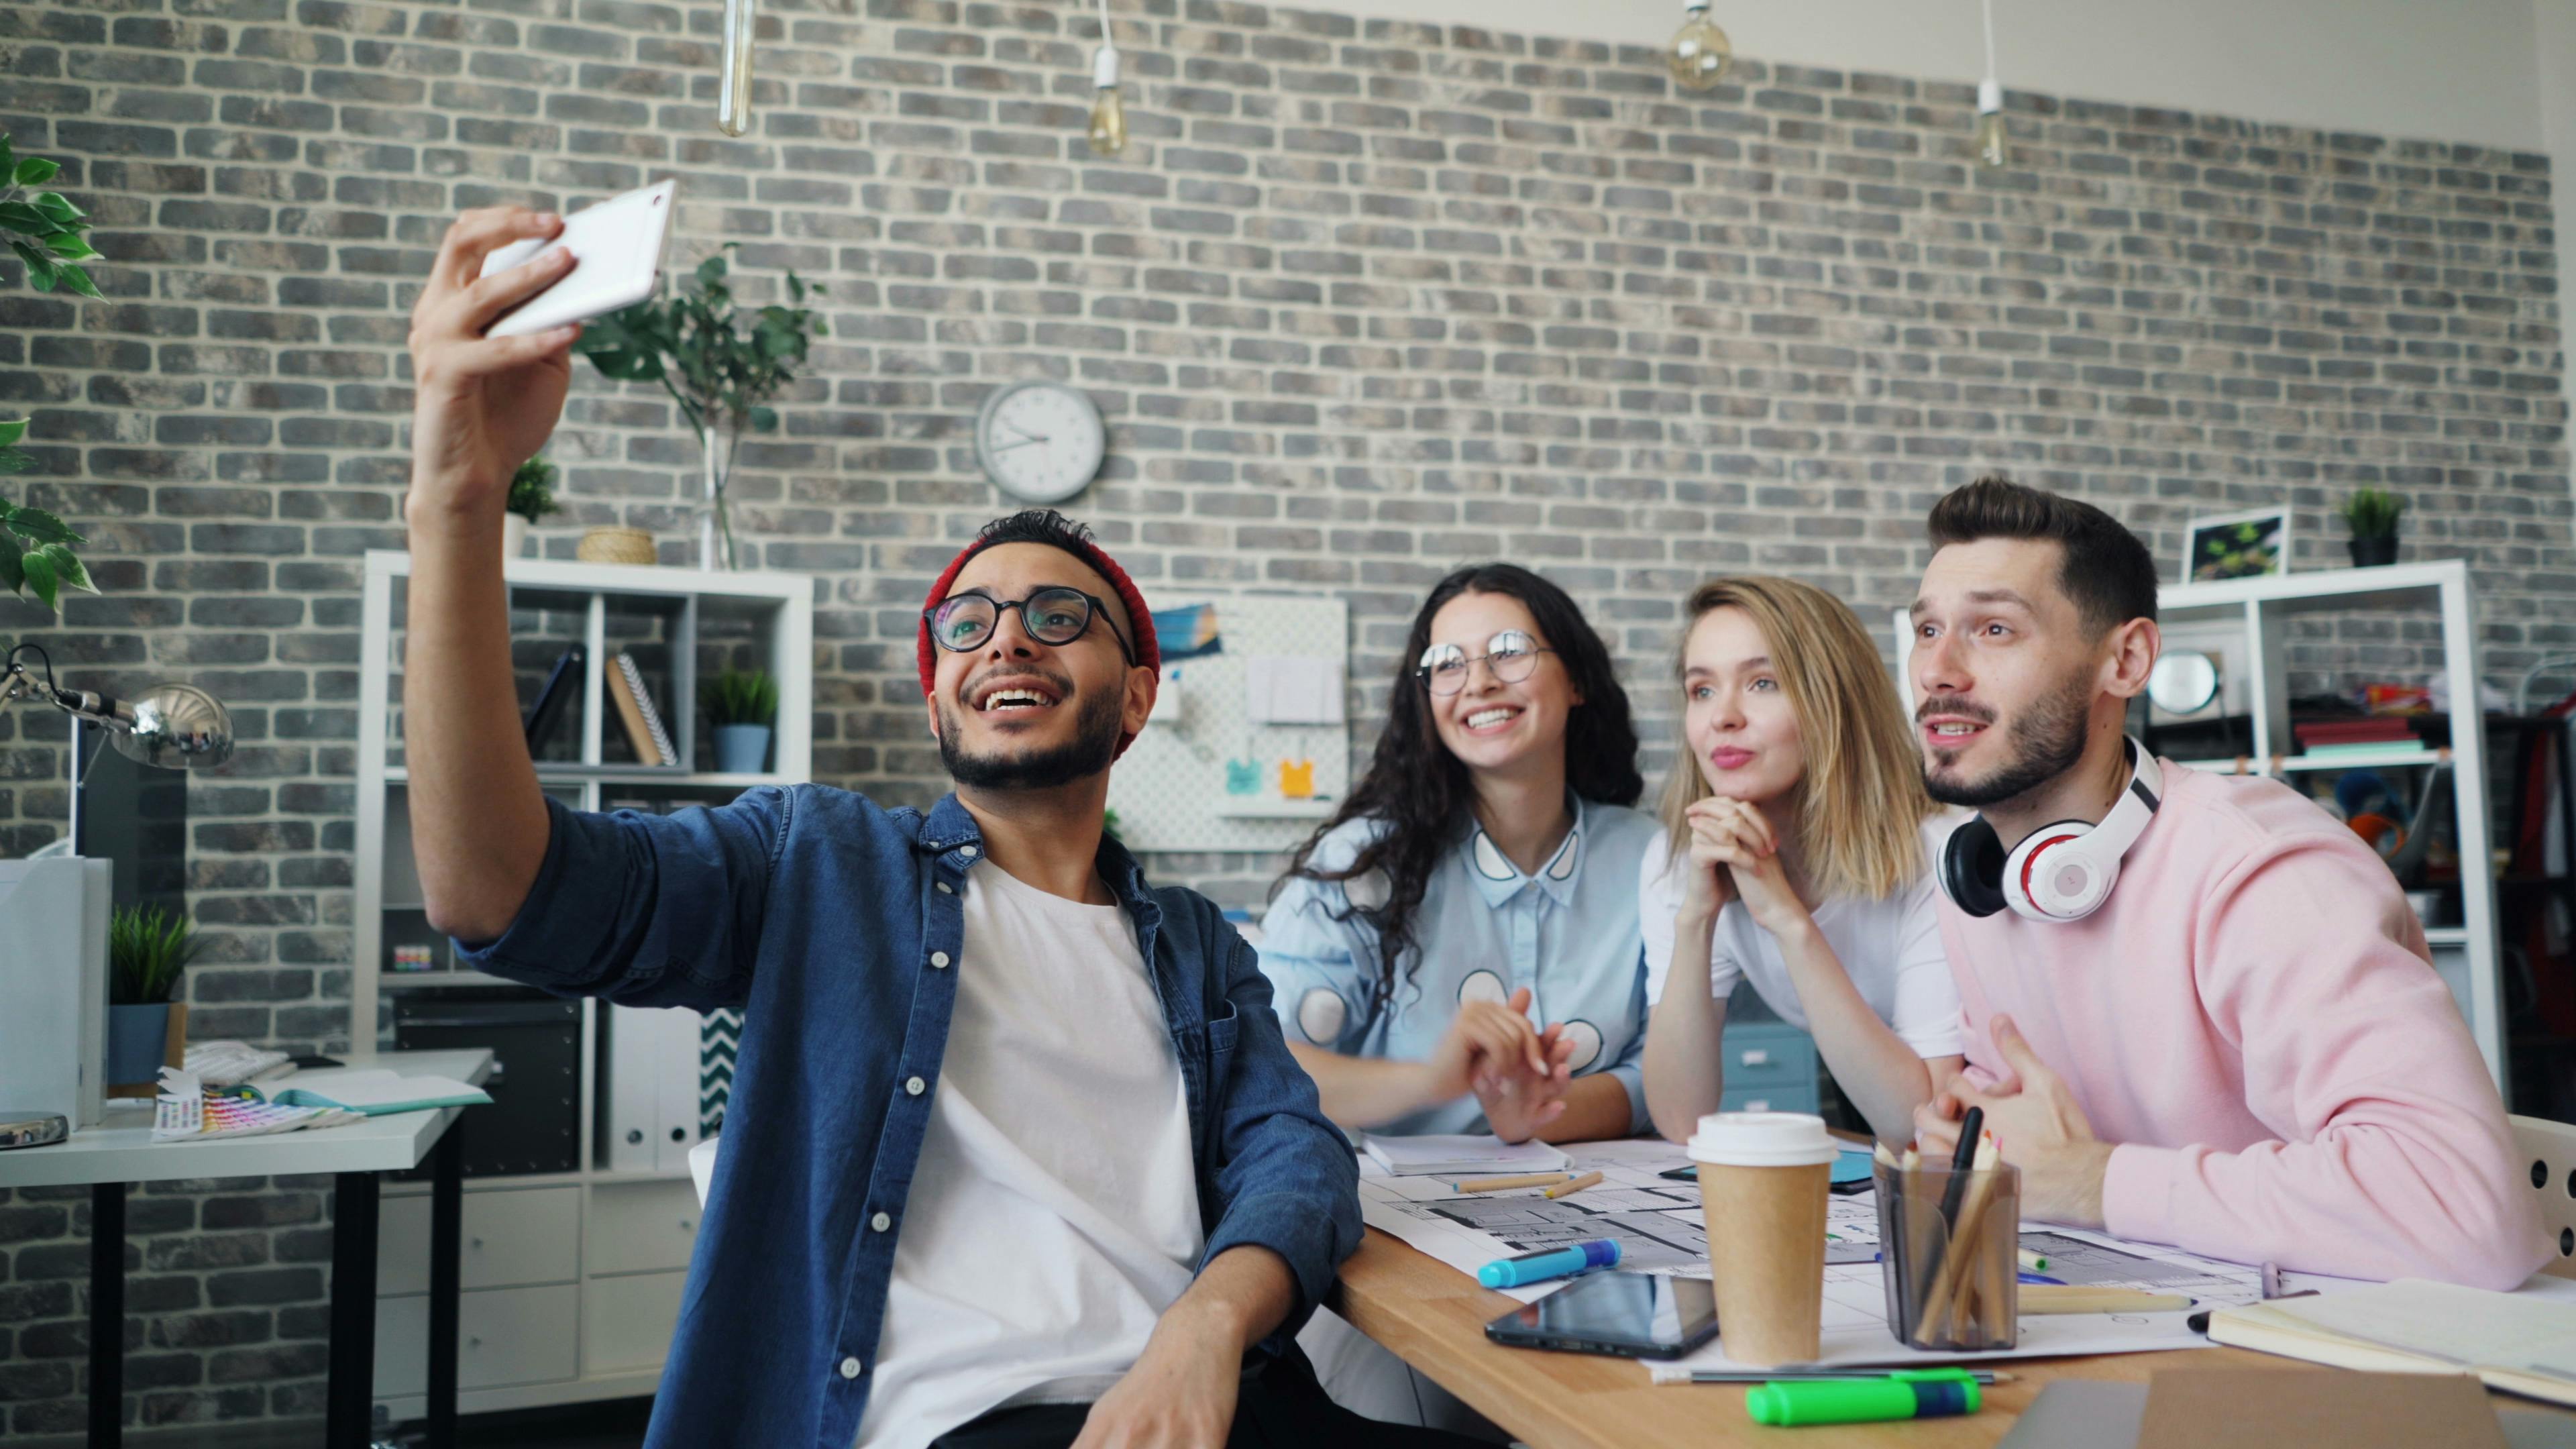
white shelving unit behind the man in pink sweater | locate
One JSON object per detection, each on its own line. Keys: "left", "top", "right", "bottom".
{"left": 1896, "top": 559, "right": 2506, "bottom": 1091}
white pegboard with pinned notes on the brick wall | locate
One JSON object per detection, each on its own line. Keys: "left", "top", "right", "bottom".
{"left": 1110, "top": 596, "right": 1350, "bottom": 851}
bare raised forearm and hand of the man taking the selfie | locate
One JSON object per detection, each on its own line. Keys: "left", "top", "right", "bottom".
{"left": 402, "top": 206, "right": 580, "bottom": 941}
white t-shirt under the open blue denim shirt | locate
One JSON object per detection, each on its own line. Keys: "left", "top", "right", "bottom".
{"left": 858, "top": 861, "right": 1205, "bottom": 1449}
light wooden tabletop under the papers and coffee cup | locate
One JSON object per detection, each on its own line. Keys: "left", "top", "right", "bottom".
{"left": 1334, "top": 1227, "right": 2324, "bottom": 1449}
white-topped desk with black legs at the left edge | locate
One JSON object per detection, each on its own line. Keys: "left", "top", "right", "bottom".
{"left": 0, "top": 1049, "right": 492, "bottom": 1449}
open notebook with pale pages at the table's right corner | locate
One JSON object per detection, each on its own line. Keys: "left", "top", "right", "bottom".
{"left": 2210, "top": 1279, "right": 2576, "bottom": 1405}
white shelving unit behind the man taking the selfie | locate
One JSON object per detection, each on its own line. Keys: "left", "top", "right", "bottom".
{"left": 350, "top": 551, "right": 814, "bottom": 1421}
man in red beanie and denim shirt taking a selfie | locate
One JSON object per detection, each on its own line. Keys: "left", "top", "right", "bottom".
{"left": 405, "top": 209, "right": 1466, "bottom": 1449}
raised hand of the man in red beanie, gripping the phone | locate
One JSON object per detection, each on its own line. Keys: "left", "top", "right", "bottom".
{"left": 402, "top": 206, "right": 582, "bottom": 539}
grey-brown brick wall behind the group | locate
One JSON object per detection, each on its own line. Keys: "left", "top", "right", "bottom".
{"left": 0, "top": 0, "right": 2576, "bottom": 1434}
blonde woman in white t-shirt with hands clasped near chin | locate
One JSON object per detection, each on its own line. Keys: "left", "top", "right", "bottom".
{"left": 1638, "top": 578, "right": 1963, "bottom": 1142}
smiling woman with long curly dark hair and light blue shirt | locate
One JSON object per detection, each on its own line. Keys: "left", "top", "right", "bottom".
{"left": 1263, "top": 562, "right": 1656, "bottom": 1142}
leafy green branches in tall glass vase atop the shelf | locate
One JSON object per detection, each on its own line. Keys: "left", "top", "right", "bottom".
{"left": 574, "top": 242, "right": 827, "bottom": 570}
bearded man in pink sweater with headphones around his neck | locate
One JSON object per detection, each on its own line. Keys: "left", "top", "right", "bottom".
{"left": 1911, "top": 480, "right": 2551, "bottom": 1289}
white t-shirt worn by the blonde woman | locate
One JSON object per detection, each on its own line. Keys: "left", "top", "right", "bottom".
{"left": 1635, "top": 810, "right": 1968, "bottom": 1057}
